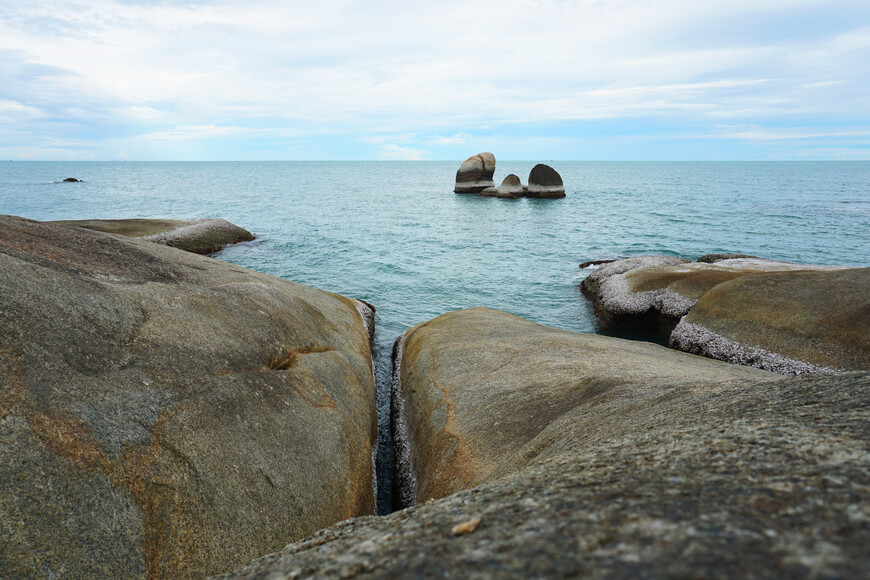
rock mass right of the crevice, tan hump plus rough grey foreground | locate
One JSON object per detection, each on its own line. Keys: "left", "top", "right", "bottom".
{"left": 223, "top": 309, "right": 870, "bottom": 579}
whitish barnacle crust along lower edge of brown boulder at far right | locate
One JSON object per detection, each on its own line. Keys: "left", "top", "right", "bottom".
{"left": 669, "top": 320, "right": 836, "bottom": 375}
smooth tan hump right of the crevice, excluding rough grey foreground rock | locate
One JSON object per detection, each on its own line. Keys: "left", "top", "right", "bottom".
{"left": 393, "top": 308, "right": 773, "bottom": 507}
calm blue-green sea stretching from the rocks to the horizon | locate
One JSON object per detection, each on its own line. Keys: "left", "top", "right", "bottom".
{"left": 0, "top": 160, "right": 870, "bottom": 512}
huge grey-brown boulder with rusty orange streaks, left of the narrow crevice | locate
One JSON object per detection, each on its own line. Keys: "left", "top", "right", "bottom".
{"left": 0, "top": 216, "right": 377, "bottom": 578}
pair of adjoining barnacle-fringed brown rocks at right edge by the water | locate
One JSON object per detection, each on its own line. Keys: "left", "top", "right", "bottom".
{"left": 582, "top": 255, "right": 870, "bottom": 374}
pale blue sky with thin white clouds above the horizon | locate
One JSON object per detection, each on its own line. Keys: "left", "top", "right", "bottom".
{"left": 0, "top": 0, "right": 870, "bottom": 160}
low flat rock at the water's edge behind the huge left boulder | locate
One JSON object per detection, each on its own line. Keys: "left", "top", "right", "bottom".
{"left": 48, "top": 218, "right": 254, "bottom": 254}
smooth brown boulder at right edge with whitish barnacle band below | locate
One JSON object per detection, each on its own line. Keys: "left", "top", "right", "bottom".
{"left": 670, "top": 262, "right": 870, "bottom": 374}
